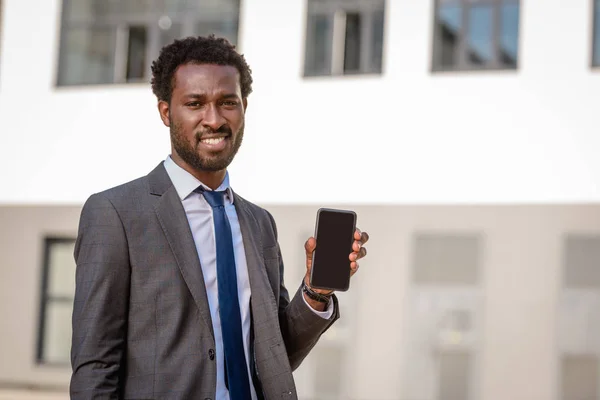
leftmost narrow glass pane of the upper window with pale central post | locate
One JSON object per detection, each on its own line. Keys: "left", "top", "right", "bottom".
{"left": 304, "top": 15, "right": 333, "bottom": 75}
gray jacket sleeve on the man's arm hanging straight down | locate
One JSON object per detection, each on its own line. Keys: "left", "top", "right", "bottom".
{"left": 70, "top": 194, "right": 130, "bottom": 400}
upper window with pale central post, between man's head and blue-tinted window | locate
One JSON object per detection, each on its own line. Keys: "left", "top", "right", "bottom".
{"left": 304, "top": 0, "right": 385, "bottom": 76}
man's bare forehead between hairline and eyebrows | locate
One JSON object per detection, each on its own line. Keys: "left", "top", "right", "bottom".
{"left": 173, "top": 64, "right": 241, "bottom": 97}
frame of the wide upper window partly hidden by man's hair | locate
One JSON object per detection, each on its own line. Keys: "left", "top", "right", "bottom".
{"left": 54, "top": 0, "right": 243, "bottom": 88}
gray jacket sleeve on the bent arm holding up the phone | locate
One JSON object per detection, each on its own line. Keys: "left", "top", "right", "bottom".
{"left": 267, "top": 212, "right": 340, "bottom": 371}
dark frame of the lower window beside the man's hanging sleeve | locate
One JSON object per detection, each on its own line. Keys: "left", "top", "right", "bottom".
{"left": 35, "top": 236, "right": 76, "bottom": 367}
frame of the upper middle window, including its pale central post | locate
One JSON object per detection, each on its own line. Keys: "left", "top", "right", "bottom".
{"left": 302, "top": 0, "right": 387, "bottom": 78}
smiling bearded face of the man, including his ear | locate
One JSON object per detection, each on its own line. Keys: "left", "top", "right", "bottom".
{"left": 159, "top": 64, "right": 246, "bottom": 172}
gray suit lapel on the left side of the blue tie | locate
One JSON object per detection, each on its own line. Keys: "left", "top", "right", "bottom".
{"left": 148, "top": 163, "right": 214, "bottom": 338}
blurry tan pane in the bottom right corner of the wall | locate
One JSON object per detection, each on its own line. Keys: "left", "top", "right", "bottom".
{"left": 561, "top": 356, "right": 600, "bottom": 400}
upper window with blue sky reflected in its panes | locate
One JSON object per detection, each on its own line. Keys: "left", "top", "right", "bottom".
{"left": 433, "top": 0, "right": 520, "bottom": 71}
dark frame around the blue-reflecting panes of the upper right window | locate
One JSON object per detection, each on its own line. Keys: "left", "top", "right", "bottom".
{"left": 430, "top": 0, "right": 522, "bottom": 74}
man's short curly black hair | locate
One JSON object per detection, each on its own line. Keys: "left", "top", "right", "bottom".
{"left": 151, "top": 35, "right": 252, "bottom": 102}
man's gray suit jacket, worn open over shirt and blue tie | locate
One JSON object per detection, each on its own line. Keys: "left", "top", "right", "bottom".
{"left": 70, "top": 163, "right": 339, "bottom": 400}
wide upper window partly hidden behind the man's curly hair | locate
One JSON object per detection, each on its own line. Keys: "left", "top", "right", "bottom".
{"left": 58, "top": 0, "right": 239, "bottom": 86}
